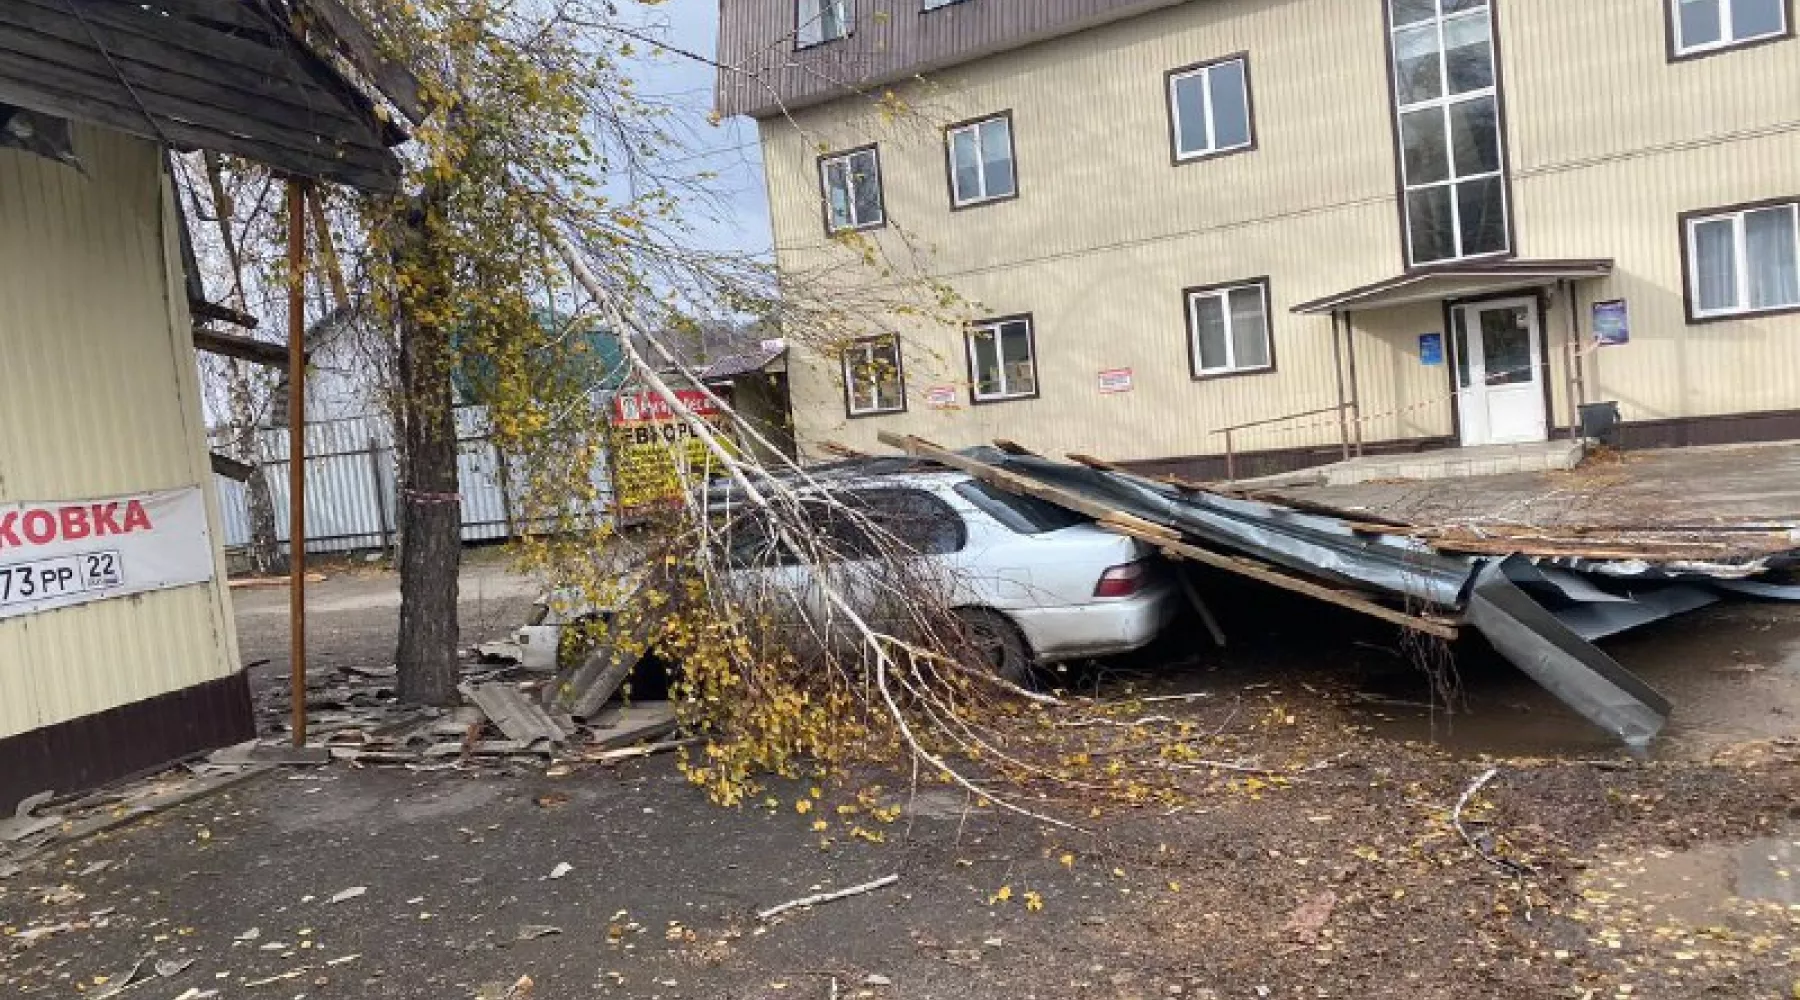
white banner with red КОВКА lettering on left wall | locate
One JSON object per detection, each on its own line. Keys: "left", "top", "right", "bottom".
{"left": 0, "top": 486, "right": 212, "bottom": 619}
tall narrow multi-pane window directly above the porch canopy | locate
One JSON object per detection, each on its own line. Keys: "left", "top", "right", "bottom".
{"left": 1382, "top": 0, "right": 1512, "bottom": 268}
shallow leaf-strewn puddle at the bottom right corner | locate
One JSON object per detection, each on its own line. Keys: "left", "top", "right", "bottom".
{"left": 1582, "top": 838, "right": 1800, "bottom": 926}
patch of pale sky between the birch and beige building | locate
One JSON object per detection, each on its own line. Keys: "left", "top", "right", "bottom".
{"left": 622, "top": 0, "right": 770, "bottom": 262}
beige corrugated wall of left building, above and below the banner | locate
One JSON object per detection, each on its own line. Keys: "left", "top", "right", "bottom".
{"left": 0, "top": 128, "right": 238, "bottom": 736}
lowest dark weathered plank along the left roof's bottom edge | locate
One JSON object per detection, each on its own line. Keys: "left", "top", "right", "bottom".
{"left": 0, "top": 67, "right": 400, "bottom": 191}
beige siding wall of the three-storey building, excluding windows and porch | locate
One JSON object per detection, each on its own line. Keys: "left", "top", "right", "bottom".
{"left": 763, "top": 0, "right": 1800, "bottom": 460}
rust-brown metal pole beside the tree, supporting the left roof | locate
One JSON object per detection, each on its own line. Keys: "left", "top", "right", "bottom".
{"left": 288, "top": 180, "right": 306, "bottom": 748}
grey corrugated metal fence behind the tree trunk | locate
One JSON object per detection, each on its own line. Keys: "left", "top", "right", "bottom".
{"left": 214, "top": 406, "right": 612, "bottom": 552}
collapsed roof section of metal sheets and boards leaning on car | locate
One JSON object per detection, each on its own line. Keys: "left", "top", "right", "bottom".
{"left": 882, "top": 433, "right": 1800, "bottom": 745}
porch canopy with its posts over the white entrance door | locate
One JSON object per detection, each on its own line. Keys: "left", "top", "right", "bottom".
{"left": 1281, "top": 257, "right": 1613, "bottom": 459}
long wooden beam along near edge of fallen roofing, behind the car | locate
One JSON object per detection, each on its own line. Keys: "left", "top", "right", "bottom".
{"left": 880, "top": 432, "right": 1456, "bottom": 638}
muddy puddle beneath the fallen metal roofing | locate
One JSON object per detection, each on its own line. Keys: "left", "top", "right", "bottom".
{"left": 1359, "top": 603, "right": 1800, "bottom": 759}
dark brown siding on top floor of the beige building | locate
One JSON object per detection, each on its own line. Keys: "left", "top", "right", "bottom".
{"left": 718, "top": 0, "right": 1197, "bottom": 117}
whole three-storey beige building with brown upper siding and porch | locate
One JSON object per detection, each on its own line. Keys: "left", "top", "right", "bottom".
{"left": 720, "top": 0, "right": 1800, "bottom": 475}
